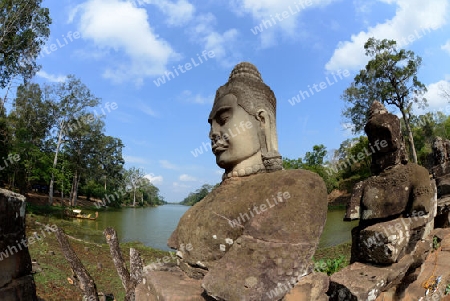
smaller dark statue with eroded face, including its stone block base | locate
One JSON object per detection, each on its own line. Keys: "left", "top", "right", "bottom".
{"left": 329, "top": 101, "right": 436, "bottom": 301}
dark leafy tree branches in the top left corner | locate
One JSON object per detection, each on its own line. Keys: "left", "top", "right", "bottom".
{"left": 0, "top": 0, "right": 52, "bottom": 89}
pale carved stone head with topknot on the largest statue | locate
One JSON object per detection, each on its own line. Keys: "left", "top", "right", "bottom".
{"left": 208, "top": 62, "right": 282, "bottom": 179}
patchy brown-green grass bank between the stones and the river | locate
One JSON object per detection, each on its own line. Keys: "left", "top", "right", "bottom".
{"left": 27, "top": 207, "right": 350, "bottom": 301}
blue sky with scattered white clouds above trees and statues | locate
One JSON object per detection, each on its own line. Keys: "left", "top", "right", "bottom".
{"left": 14, "top": 0, "right": 450, "bottom": 202}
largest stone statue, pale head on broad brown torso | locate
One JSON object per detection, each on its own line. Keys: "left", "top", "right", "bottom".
{"left": 137, "top": 63, "right": 327, "bottom": 301}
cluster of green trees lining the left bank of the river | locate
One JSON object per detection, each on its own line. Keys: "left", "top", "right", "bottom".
{"left": 0, "top": 75, "right": 165, "bottom": 207}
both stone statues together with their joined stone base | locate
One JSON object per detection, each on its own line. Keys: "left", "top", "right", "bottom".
{"left": 137, "top": 62, "right": 450, "bottom": 301}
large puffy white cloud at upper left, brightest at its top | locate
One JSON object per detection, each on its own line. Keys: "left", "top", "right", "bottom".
{"left": 69, "top": 0, "right": 178, "bottom": 85}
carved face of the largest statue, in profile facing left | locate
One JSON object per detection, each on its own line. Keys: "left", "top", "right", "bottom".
{"left": 208, "top": 94, "right": 262, "bottom": 172}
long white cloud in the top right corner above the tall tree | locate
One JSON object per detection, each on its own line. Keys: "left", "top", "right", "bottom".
{"left": 325, "top": 0, "right": 449, "bottom": 71}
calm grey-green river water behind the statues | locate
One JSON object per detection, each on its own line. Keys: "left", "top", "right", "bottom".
{"left": 73, "top": 204, "right": 358, "bottom": 251}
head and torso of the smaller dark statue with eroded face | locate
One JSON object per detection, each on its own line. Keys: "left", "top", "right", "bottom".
{"left": 346, "top": 101, "right": 435, "bottom": 225}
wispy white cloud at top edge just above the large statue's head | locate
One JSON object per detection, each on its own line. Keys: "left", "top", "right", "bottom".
{"left": 231, "top": 0, "right": 335, "bottom": 48}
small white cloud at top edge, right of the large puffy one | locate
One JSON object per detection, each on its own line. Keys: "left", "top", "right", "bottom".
{"left": 137, "top": 0, "right": 195, "bottom": 26}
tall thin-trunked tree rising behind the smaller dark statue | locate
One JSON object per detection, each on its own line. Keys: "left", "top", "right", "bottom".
{"left": 341, "top": 38, "right": 427, "bottom": 163}
